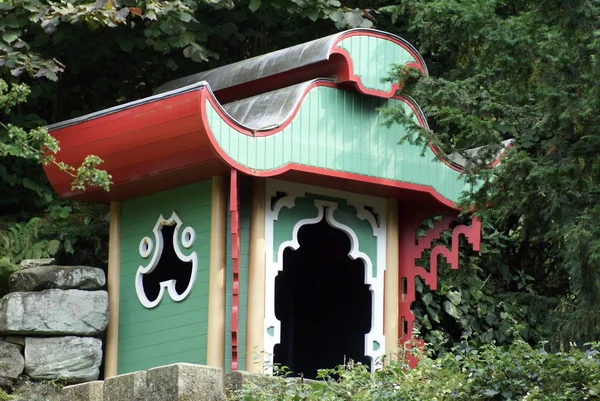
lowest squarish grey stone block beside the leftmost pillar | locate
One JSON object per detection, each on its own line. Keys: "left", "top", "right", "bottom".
{"left": 25, "top": 336, "right": 102, "bottom": 383}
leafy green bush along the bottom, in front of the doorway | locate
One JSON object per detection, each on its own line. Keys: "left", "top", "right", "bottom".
{"left": 238, "top": 339, "right": 600, "bottom": 401}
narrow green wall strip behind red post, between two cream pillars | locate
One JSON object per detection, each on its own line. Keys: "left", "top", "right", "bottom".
{"left": 225, "top": 176, "right": 252, "bottom": 371}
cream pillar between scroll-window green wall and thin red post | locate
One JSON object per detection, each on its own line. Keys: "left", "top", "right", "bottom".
{"left": 206, "top": 176, "right": 227, "bottom": 369}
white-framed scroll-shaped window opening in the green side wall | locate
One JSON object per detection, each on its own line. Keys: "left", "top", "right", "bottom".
{"left": 135, "top": 212, "right": 198, "bottom": 308}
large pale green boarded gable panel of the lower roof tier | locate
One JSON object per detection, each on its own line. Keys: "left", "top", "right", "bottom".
{"left": 206, "top": 86, "right": 465, "bottom": 202}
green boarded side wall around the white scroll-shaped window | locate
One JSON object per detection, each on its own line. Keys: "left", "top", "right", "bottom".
{"left": 118, "top": 181, "right": 211, "bottom": 374}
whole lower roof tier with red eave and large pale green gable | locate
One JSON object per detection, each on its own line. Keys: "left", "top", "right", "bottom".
{"left": 45, "top": 80, "right": 510, "bottom": 207}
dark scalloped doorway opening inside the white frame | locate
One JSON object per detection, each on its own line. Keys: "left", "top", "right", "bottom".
{"left": 274, "top": 214, "right": 372, "bottom": 378}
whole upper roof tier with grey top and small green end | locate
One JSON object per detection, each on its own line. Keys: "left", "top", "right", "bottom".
{"left": 155, "top": 28, "right": 427, "bottom": 103}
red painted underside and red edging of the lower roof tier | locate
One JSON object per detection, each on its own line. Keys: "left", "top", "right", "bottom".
{"left": 44, "top": 76, "right": 504, "bottom": 208}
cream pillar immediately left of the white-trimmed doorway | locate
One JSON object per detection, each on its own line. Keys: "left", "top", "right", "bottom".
{"left": 246, "top": 178, "right": 266, "bottom": 373}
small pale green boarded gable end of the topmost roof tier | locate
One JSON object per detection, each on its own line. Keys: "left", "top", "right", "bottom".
{"left": 337, "top": 36, "right": 417, "bottom": 92}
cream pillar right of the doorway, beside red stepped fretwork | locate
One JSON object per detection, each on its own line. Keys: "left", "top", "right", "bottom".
{"left": 384, "top": 199, "right": 400, "bottom": 358}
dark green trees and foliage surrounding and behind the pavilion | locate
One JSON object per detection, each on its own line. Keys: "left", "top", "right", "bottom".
{"left": 0, "top": 0, "right": 600, "bottom": 366}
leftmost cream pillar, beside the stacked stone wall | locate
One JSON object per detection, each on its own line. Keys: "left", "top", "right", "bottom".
{"left": 104, "top": 201, "right": 121, "bottom": 378}
